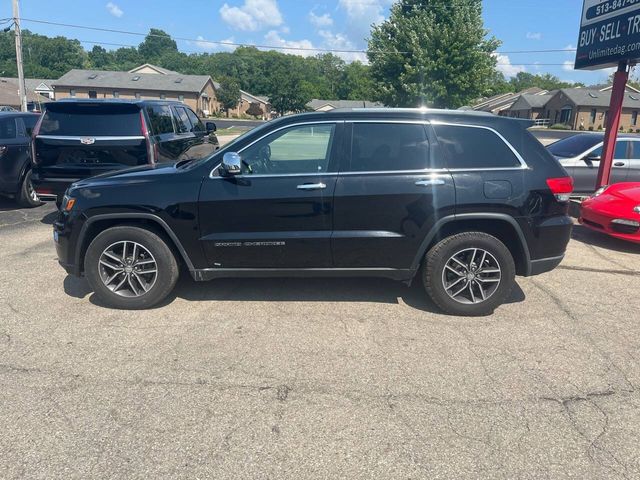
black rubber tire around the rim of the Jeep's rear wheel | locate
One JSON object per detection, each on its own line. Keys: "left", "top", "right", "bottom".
{"left": 422, "top": 232, "right": 516, "bottom": 316}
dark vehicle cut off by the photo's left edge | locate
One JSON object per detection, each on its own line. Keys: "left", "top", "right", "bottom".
{"left": 0, "top": 112, "right": 40, "bottom": 207}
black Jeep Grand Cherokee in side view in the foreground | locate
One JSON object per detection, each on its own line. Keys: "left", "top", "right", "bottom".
{"left": 54, "top": 109, "right": 572, "bottom": 315}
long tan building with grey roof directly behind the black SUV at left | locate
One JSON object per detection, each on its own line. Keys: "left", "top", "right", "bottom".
{"left": 52, "top": 68, "right": 220, "bottom": 116}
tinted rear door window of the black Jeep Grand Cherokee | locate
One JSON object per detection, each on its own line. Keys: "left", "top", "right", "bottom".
{"left": 348, "top": 123, "right": 429, "bottom": 172}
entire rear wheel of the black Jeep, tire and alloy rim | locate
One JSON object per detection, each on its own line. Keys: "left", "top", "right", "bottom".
{"left": 423, "top": 232, "right": 516, "bottom": 316}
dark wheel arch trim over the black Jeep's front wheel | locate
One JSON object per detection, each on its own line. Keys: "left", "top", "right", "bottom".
{"left": 75, "top": 213, "right": 195, "bottom": 272}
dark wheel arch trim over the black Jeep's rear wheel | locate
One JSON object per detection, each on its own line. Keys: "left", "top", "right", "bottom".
{"left": 412, "top": 213, "right": 531, "bottom": 276}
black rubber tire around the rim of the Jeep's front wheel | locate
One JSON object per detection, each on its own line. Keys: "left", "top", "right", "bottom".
{"left": 84, "top": 226, "right": 179, "bottom": 310}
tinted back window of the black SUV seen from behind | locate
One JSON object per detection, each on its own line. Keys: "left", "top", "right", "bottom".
{"left": 39, "top": 104, "right": 142, "bottom": 137}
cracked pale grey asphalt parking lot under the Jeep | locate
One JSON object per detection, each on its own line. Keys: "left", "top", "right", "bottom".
{"left": 0, "top": 200, "right": 640, "bottom": 479}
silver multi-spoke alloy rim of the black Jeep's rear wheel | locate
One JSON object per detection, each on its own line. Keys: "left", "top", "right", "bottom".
{"left": 442, "top": 248, "right": 502, "bottom": 304}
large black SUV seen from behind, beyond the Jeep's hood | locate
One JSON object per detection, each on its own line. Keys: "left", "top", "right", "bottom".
{"left": 33, "top": 100, "right": 219, "bottom": 204}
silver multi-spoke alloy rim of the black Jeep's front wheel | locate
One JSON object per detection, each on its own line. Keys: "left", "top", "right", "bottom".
{"left": 98, "top": 241, "right": 158, "bottom": 298}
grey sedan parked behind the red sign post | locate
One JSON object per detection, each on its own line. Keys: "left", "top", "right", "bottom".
{"left": 547, "top": 133, "right": 640, "bottom": 195}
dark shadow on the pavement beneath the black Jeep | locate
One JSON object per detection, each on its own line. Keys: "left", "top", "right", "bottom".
{"left": 74, "top": 274, "right": 525, "bottom": 314}
